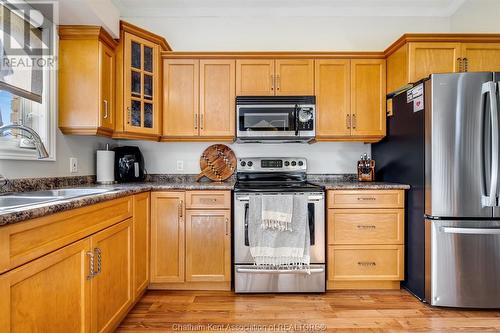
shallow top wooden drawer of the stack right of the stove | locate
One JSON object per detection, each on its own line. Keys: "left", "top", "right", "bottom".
{"left": 328, "top": 190, "right": 404, "bottom": 208}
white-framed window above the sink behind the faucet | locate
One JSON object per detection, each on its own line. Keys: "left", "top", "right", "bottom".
{"left": 0, "top": 0, "right": 57, "bottom": 160}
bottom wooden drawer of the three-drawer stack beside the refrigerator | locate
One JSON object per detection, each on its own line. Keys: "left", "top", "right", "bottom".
{"left": 328, "top": 245, "right": 404, "bottom": 281}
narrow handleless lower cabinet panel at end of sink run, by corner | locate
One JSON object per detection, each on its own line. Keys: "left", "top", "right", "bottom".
{"left": 133, "top": 192, "right": 150, "bottom": 298}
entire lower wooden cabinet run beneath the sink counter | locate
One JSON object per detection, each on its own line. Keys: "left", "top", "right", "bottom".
{"left": 0, "top": 193, "right": 149, "bottom": 333}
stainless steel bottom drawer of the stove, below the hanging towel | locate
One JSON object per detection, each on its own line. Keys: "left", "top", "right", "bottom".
{"left": 234, "top": 265, "right": 326, "bottom": 293}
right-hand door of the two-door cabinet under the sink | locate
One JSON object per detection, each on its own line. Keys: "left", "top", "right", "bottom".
{"left": 91, "top": 219, "right": 133, "bottom": 333}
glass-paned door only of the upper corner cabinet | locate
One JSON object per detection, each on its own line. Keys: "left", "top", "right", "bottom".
{"left": 124, "top": 33, "right": 161, "bottom": 135}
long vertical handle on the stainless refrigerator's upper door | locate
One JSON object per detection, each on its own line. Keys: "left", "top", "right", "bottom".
{"left": 481, "top": 81, "right": 499, "bottom": 207}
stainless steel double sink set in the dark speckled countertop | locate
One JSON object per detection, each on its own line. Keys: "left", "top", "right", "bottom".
{"left": 0, "top": 188, "right": 116, "bottom": 213}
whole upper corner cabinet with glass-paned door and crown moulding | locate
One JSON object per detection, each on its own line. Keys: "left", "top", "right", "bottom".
{"left": 113, "top": 21, "right": 170, "bottom": 140}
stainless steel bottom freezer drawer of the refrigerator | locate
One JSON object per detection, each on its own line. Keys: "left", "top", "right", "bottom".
{"left": 426, "top": 220, "right": 500, "bottom": 308}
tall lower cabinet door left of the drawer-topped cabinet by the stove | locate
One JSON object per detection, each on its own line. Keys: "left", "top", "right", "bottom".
{"left": 150, "top": 192, "right": 185, "bottom": 283}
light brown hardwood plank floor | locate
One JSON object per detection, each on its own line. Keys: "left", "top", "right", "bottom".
{"left": 117, "top": 290, "right": 500, "bottom": 332}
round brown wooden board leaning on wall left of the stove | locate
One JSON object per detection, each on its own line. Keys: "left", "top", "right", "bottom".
{"left": 196, "top": 144, "right": 237, "bottom": 182}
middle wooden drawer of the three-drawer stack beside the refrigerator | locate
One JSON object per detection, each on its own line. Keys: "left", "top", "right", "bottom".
{"left": 328, "top": 209, "right": 404, "bottom": 245}
